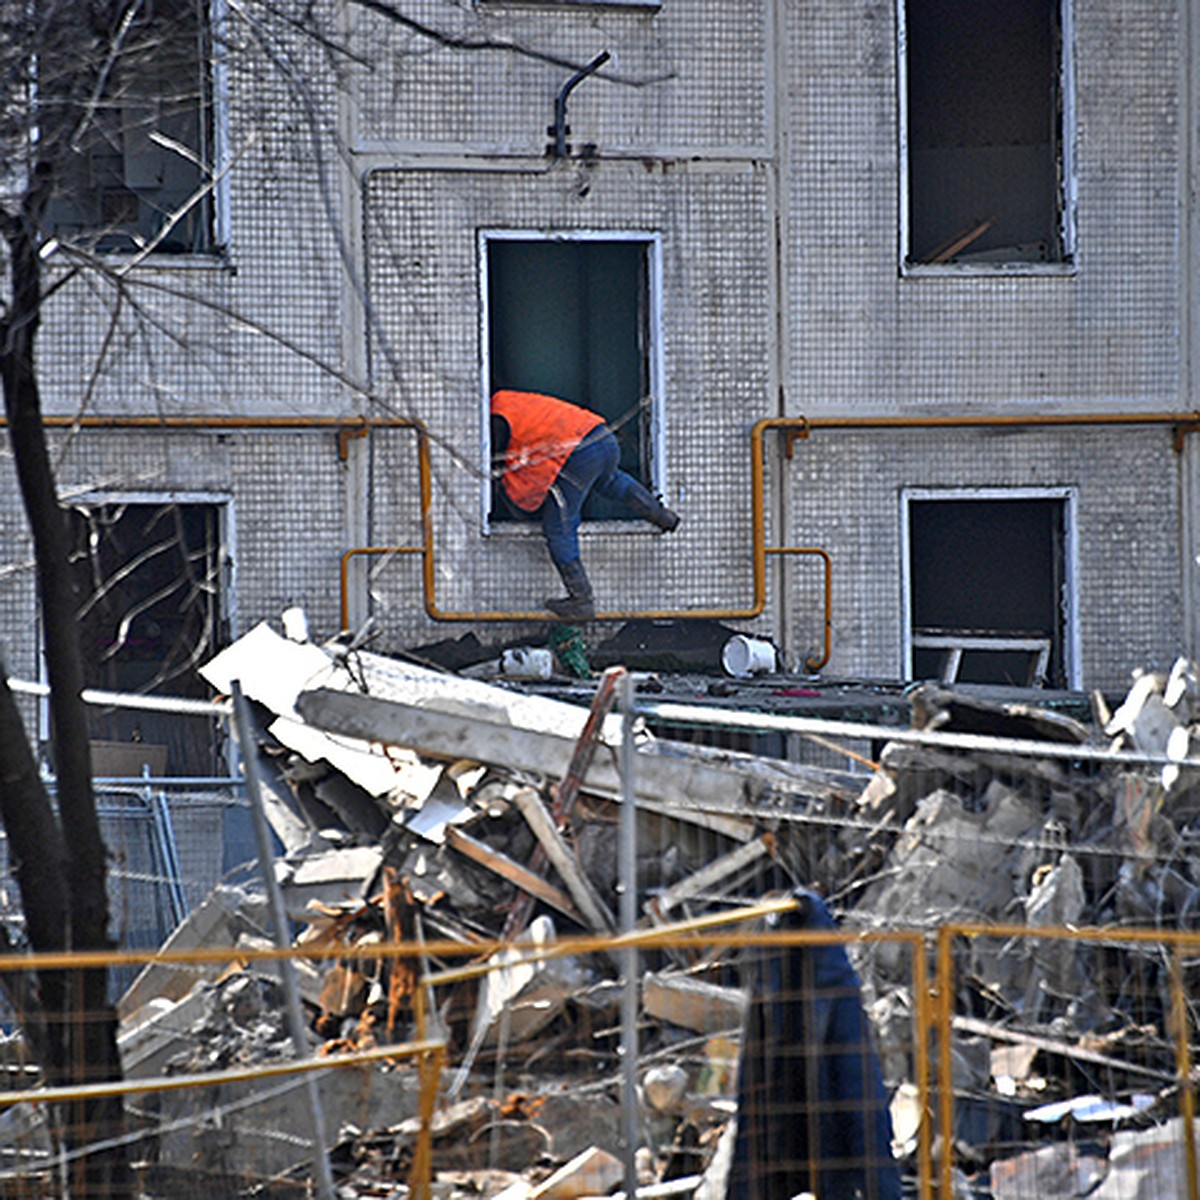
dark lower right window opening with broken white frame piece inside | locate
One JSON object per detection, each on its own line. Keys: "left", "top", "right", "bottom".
{"left": 906, "top": 496, "right": 1073, "bottom": 688}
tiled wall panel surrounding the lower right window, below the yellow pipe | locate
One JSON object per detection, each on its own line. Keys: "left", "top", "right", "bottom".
{"left": 782, "top": 428, "right": 1182, "bottom": 694}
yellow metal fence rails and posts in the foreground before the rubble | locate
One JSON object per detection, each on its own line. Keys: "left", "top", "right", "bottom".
{"left": 0, "top": 916, "right": 1200, "bottom": 1200}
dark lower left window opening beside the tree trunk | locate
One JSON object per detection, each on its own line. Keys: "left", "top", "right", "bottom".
{"left": 71, "top": 503, "right": 227, "bottom": 776}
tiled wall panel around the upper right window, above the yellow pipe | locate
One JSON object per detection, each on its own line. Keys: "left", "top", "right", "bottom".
{"left": 785, "top": 0, "right": 1181, "bottom": 413}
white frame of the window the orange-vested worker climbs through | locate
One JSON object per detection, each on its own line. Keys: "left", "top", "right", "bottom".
{"left": 476, "top": 229, "right": 667, "bottom": 534}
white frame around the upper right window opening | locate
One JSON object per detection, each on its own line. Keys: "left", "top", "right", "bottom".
{"left": 896, "top": 0, "right": 1078, "bottom": 276}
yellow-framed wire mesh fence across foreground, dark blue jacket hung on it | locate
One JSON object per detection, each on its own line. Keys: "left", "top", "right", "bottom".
{"left": 0, "top": 912, "right": 1200, "bottom": 1200}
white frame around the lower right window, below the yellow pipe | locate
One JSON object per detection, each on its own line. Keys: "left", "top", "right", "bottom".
{"left": 900, "top": 487, "right": 1082, "bottom": 691}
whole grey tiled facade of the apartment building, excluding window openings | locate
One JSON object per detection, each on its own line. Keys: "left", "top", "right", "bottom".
{"left": 0, "top": 0, "right": 1194, "bottom": 689}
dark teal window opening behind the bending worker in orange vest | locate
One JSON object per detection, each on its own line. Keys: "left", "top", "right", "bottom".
{"left": 482, "top": 234, "right": 662, "bottom": 521}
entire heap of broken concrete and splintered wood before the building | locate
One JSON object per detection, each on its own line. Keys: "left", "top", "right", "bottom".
{"left": 42, "top": 624, "right": 1200, "bottom": 1200}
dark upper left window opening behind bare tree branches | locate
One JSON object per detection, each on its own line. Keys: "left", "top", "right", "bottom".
{"left": 42, "top": 0, "right": 215, "bottom": 254}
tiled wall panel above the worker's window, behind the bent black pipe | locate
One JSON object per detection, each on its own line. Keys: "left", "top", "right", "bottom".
{"left": 354, "top": 0, "right": 772, "bottom": 158}
